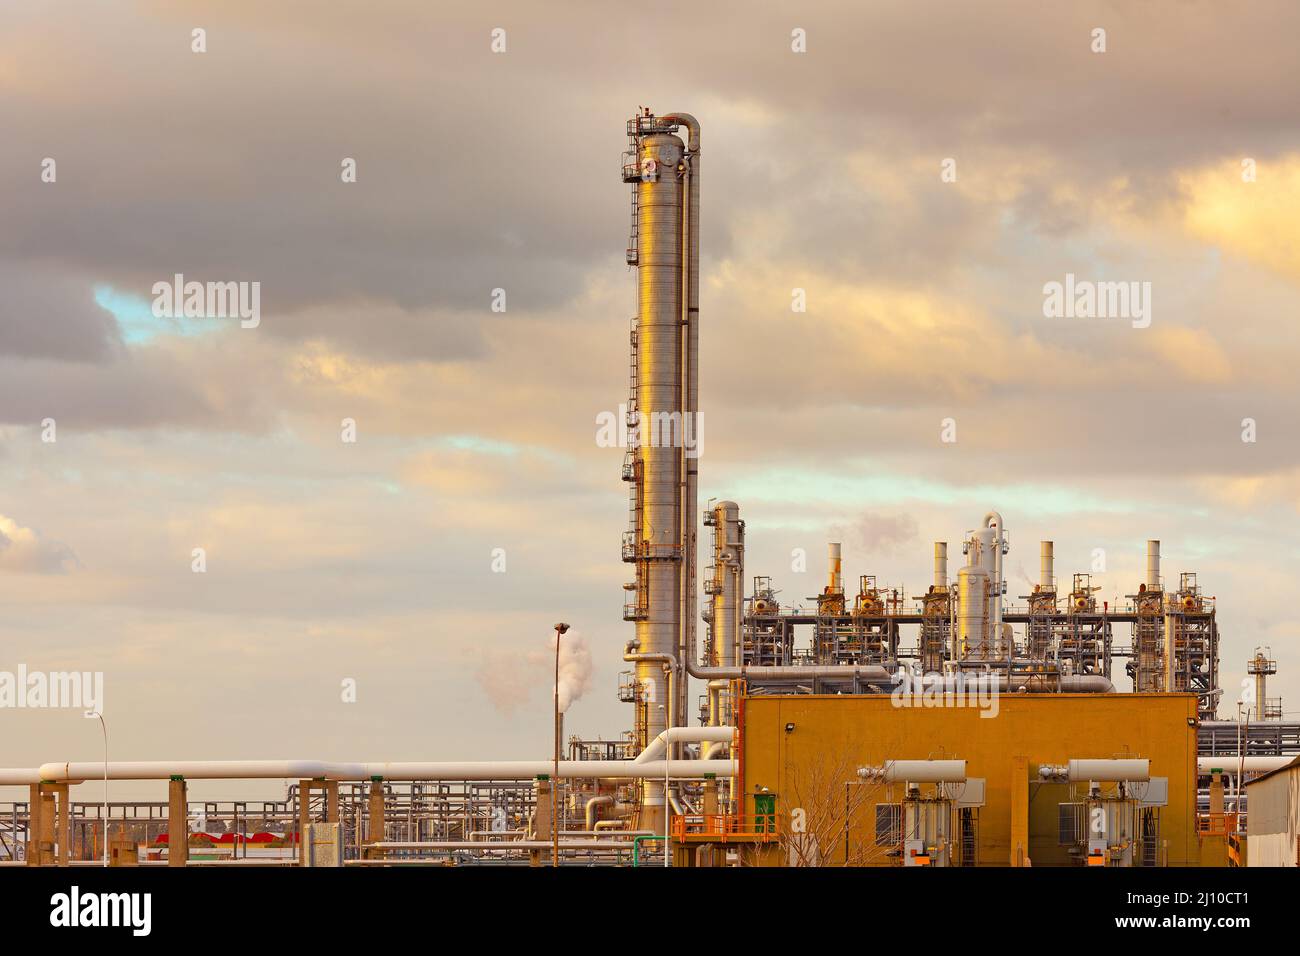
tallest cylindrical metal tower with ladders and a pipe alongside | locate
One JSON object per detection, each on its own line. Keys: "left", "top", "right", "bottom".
{"left": 623, "top": 109, "right": 701, "bottom": 829}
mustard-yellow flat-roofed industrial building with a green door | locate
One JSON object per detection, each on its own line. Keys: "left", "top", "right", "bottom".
{"left": 740, "top": 693, "right": 1201, "bottom": 866}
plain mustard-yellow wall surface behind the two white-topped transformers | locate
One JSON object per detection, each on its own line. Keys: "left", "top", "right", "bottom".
{"left": 741, "top": 693, "right": 1201, "bottom": 866}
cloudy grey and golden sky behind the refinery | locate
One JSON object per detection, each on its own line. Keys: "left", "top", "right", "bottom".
{"left": 0, "top": 0, "right": 1300, "bottom": 799}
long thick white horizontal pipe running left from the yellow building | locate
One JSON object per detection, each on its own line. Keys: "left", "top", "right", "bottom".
{"left": 22, "top": 759, "right": 736, "bottom": 784}
